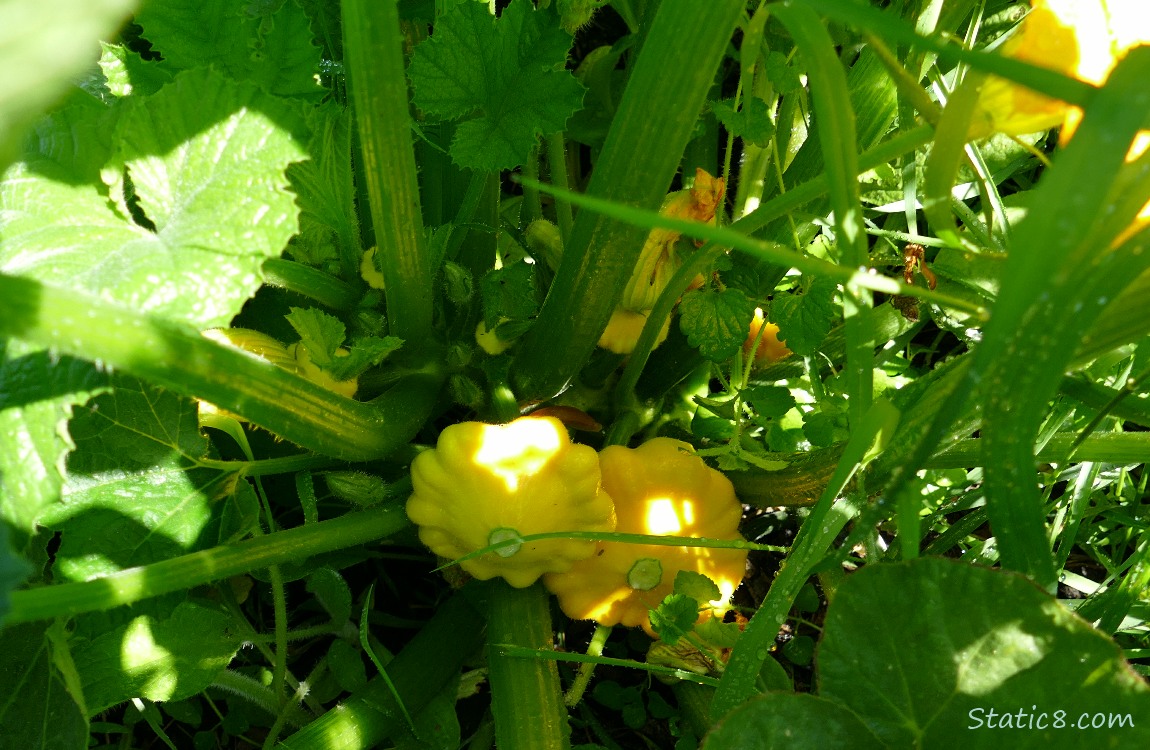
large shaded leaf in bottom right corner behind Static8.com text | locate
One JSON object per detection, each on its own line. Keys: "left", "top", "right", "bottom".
{"left": 705, "top": 558, "right": 1150, "bottom": 750}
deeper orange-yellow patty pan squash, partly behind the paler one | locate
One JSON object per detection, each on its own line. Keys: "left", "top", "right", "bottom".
{"left": 543, "top": 437, "right": 746, "bottom": 636}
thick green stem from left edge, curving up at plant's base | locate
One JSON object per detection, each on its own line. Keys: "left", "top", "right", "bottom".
{"left": 0, "top": 274, "right": 443, "bottom": 460}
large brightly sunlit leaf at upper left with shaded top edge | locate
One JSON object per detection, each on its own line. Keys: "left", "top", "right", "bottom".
{"left": 0, "top": 70, "right": 305, "bottom": 327}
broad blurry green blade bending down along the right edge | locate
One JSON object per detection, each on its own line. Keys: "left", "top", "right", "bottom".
{"left": 888, "top": 49, "right": 1150, "bottom": 588}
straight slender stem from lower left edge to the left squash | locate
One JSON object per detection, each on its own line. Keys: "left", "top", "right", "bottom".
{"left": 5, "top": 505, "right": 409, "bottom": 625}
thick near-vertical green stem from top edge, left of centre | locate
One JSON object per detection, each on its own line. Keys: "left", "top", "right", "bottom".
{"left": 342, "top": 0, "right": 431, "bottom": 342}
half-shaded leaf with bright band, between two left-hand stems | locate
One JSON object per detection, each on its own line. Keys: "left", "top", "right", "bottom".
{"left": 38, "top": 377, "right": 240, "bottom": 581}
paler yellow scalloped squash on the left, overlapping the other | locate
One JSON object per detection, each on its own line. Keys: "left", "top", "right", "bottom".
{"left": 407, "top": 416, "right": 615, "bottom": 588}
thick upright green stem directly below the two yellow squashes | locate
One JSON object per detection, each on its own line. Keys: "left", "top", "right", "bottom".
{"left": 488, "top": 581, "right": 570, "bottom": 750}
